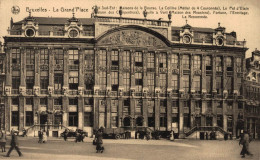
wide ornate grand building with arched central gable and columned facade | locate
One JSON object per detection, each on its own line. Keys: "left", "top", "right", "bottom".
{"left": 4, "top": 9, "right": 247, "bottom": 138}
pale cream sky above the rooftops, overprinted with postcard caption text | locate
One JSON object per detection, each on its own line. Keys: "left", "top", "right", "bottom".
{"left": 0, "top": 0, "right": 260, "bottom": 57}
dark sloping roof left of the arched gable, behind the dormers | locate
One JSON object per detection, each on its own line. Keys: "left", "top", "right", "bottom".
{"left": 14, "top": 17, "right": 95, "bottom": 25}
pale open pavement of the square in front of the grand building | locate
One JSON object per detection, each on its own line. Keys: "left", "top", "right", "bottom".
{"left": 0, "top": 137, "right": 260, "bottom": 160}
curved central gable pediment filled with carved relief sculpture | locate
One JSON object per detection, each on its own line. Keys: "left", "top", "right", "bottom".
{"left": 97, "top": 28, "right": 168, "bottom": 47}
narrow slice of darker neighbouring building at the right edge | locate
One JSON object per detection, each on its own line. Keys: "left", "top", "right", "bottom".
{"left": 245, "top": 50, "right": 260, "bottom": 138}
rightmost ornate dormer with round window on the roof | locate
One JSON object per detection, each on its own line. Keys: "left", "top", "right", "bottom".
{"left": 213, "top": 23, "right": 226, "bottom": 46}
